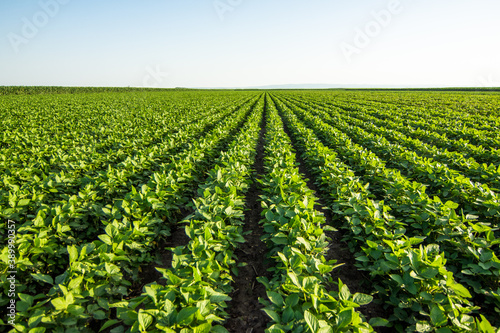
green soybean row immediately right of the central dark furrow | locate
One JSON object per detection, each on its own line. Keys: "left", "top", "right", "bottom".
{"left": 258, "top": 97, "right": 373, "bottom": 333}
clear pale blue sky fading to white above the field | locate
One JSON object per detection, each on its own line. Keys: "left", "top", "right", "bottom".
{"left": 0, "top": 0, "right": 500, "bottom": 87}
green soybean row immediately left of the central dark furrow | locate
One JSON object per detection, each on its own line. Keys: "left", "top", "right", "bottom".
{"left": 107, "top": 92, "right": 264, "bottom": 333}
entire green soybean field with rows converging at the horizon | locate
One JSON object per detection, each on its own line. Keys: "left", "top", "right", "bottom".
{"left": 0, "top": 87, "right": 500, "bottom": 333}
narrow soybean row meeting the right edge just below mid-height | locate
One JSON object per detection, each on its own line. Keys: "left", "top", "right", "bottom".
{"left": 280, "top": 92, "right": 500, "bottom": 191}
